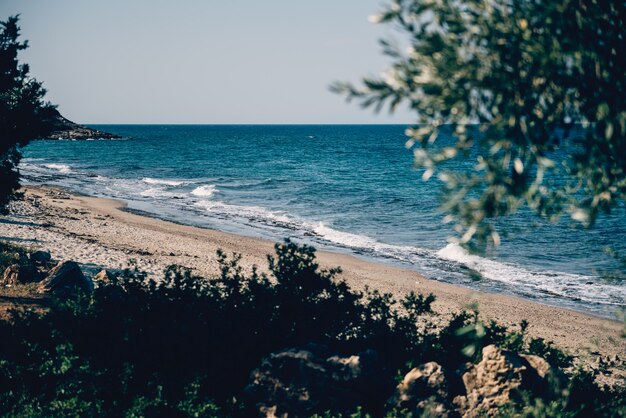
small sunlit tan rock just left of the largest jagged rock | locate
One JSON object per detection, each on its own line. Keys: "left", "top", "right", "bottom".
{"left": 390, "top": 361, "right": 457, "bottom": 418}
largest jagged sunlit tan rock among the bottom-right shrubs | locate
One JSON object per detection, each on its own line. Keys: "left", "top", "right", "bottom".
{"left": 454, "top": 345, "right": 559, "bottom": 418}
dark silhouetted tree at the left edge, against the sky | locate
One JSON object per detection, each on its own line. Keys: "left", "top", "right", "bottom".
{"left": 0, "top": 16, "right": 54, "bottom": 210}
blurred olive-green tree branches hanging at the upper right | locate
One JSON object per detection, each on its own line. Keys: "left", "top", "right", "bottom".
{"left": 332, "top": 0, "right": 626, "bottom": 246}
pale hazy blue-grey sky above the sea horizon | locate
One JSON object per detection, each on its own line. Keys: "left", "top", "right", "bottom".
{"left": 0, "top": 0, "right": 412, "bottom": 124}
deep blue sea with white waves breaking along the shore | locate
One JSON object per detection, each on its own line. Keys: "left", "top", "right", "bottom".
{"left": 20, "top": 125, "right": 626, "bottom": 317}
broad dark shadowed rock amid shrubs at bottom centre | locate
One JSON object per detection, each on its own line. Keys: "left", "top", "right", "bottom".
{"left": 245, "top": 344, "right": 382, "bottom": 417}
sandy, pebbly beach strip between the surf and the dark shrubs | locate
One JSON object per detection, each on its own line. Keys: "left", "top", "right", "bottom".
{"left": 0, "top": 186, "right": 626, "bottom": 359}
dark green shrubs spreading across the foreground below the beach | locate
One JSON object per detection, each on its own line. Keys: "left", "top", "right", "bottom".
{"left": 0, "top": 241, "right": 624, "bottom": 417}
